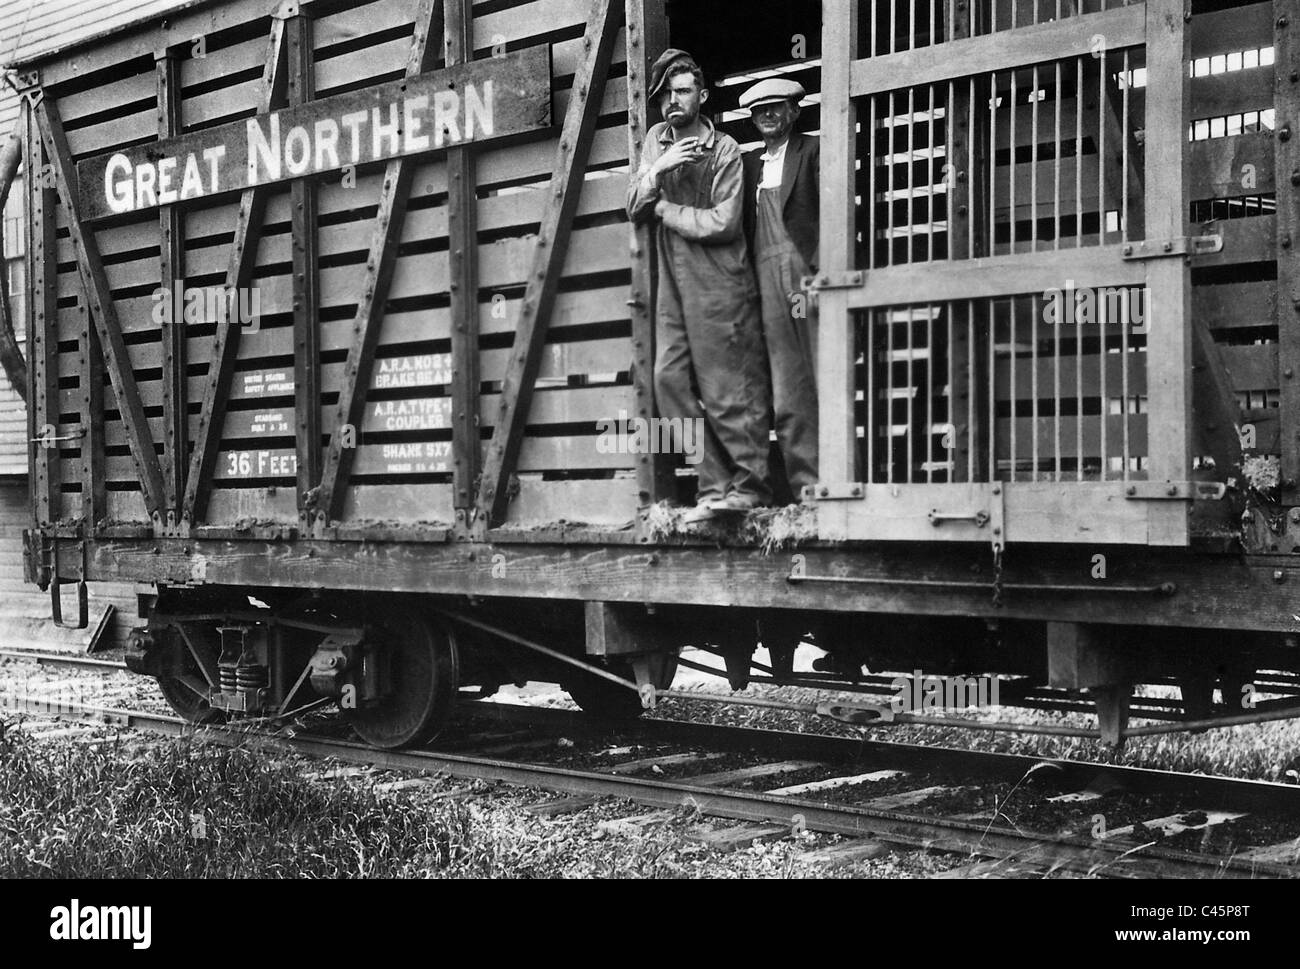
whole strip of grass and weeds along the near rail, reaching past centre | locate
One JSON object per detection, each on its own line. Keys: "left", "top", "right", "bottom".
{"left": 0, "top": 722, "right": 894, "bottom": 879}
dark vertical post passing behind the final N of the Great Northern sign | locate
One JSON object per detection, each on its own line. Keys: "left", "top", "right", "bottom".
{"left": 443, "top": 0, "right": 482, "bottom": 529}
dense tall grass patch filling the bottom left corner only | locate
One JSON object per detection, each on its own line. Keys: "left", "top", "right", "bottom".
{"left": 0, "top": 734, "right": 495, "bottom": 878}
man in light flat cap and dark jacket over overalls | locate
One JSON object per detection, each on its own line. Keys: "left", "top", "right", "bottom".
{"left": 740, "top": 78, "right": 820, "bottom": 499}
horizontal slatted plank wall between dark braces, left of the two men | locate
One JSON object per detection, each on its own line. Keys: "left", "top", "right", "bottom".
{"left": 38, "top": 0, "right": 647, "bottom": 525}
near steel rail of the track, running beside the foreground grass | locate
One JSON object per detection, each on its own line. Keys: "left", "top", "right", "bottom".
{"left": 0, "top": 704, "right": 1300, "bottom": 878}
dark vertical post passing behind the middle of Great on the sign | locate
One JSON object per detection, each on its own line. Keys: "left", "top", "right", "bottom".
{"left": 153, "top": 49, "right": 190, "bottom": 528}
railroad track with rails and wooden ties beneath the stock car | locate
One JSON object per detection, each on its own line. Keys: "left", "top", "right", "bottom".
{"left": 2, "top": 676, "right": 1300, "bottom": 878}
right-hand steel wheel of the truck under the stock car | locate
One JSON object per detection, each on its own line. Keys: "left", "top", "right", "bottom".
{"left": 348, "top": 610, "right": 460, "bottom": 750}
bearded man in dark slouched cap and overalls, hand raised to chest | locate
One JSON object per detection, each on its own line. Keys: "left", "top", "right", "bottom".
{"left": 628, "top": 48, "right": 771, "bottom": 524}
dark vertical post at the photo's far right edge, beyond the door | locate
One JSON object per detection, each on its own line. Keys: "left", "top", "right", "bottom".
{"left": 1268, "top": 0, "right": 1300, "bottom": 505}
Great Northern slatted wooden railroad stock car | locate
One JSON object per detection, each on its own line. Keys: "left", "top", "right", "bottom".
{"left": 14, "top": 0, "right": 1300, "bottom": 747}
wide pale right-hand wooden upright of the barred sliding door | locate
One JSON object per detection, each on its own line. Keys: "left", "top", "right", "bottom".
{"left": 1144, "top": 0, "right": 1192, "bottom": 545}
